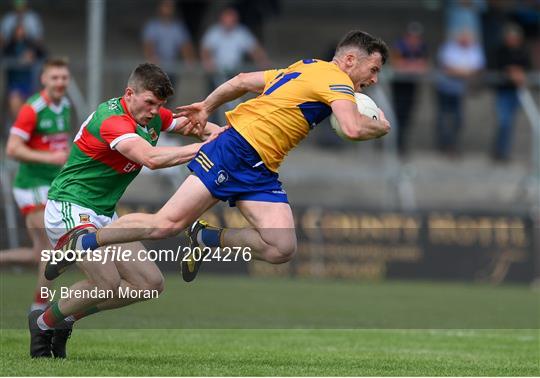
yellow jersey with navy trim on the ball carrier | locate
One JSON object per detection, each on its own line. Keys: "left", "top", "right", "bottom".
{"left": 226, "top": 59, "right": 356, "bottom": 172}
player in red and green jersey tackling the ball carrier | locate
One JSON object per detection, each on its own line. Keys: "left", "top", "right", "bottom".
{"left": 29, "top": 63, "right": 222, "bottom": 357}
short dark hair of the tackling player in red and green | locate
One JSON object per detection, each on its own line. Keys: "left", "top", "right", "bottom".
{"left": 128, "top": 63, "right": 174, "bottom": 100}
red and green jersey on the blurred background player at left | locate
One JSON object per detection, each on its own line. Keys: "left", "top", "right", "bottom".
{"left": 10, "top": 91, "right": 71, "bottom": 189}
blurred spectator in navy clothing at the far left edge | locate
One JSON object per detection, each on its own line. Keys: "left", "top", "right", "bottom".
{"left": 2, "top": 19, "right": 45, "bottom": 130}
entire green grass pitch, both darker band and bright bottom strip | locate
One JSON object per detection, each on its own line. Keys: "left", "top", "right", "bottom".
{"left": 0, "top": 272, "right": 540, "bottom": 376}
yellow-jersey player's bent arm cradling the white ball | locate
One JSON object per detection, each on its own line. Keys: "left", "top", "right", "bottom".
{"left": 331, "top": 100, "right": 390, "bottom": 140}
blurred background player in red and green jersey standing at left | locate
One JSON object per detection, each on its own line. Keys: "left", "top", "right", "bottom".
{"left": 0, "top": 59, "right": 71, "bottom": 311}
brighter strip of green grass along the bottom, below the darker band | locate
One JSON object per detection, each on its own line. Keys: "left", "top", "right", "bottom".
{"left": 0, "top": 330, "right": 540, "bottom": 376}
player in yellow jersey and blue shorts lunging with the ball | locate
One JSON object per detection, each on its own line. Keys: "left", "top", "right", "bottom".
{"left": 49, "top": 31, "right": 390, "bottom": 284}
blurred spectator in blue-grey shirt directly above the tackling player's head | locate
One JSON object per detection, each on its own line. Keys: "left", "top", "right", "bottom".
{"left": 143, "top": 0, "right": 195, "bottom": 92}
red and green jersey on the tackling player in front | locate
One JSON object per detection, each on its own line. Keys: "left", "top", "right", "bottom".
{"left": 49, "top": 98, "right": 176, "bottom": 217}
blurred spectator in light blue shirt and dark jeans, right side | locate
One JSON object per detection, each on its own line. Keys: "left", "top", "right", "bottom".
{"left": 436, "top": 29, "right": 485, "bottom": 155}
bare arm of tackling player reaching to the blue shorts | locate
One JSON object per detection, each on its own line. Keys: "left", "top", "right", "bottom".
{"left": 115, "top": 137, "right": 204, "bottom": 169}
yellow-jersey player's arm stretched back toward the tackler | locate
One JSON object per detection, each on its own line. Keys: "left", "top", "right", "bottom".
{"left": 174, "top": 71, "right": 265, "bottom": 127}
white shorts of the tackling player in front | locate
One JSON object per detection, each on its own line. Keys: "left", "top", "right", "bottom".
{"left": 45, "top": 200, "right": 118, "bottom": 247}
